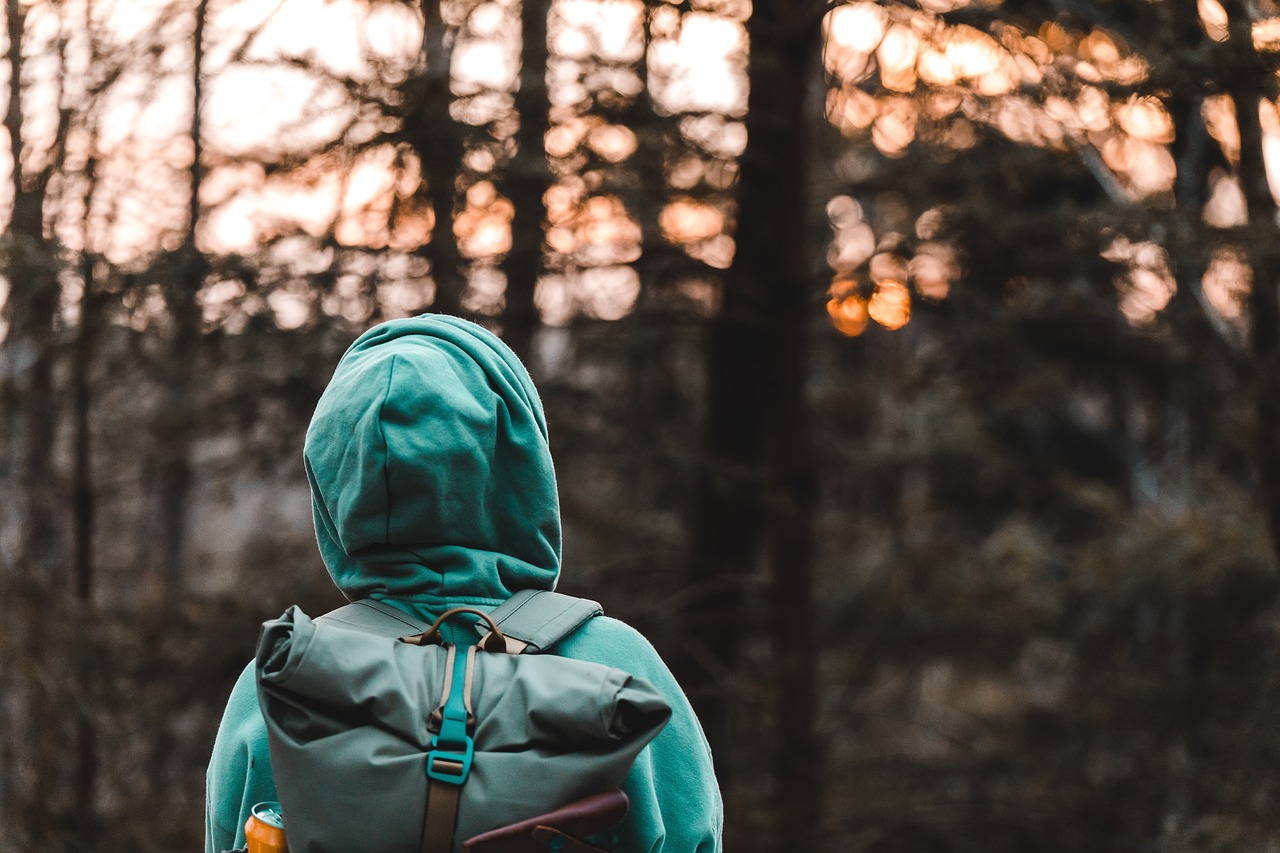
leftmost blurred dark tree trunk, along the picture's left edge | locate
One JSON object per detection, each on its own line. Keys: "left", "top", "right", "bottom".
{"left": 0, "top": 0, "right": 69, "bottom": 845}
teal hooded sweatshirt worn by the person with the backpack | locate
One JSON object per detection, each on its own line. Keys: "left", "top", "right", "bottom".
{"left": 205, "top": 315, "right": 723, "bottom": 853}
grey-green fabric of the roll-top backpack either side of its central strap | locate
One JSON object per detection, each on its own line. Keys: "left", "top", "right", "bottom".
{"left": 250, "top": 607, "right": 671, "bottom": 853}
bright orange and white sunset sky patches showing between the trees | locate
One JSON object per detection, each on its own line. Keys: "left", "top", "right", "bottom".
{"left": 4, "top": 0, "right": 1280, "bottom": 343}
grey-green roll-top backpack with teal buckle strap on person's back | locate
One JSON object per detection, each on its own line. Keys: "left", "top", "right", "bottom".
{"left": 256, "top": 590, "right": 671, "bottom": 853}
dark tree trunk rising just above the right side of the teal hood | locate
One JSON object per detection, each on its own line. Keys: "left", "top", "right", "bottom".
{"left": 502, "top": 0, "right": 552, "bottom": 362}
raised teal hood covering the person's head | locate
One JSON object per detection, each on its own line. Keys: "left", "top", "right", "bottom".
{"left": 303, "top": 314, "right": 561, "bottom": 605}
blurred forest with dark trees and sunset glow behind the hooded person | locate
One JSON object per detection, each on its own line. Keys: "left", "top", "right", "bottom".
{"left": 0, "top": 0, "right": 1280, "bottom": 853}
